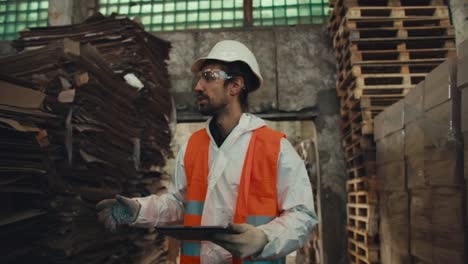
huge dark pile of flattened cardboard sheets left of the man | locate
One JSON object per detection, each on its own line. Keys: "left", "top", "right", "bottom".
{"left": 0, "top": 23, "right": 172, "bottom": 263}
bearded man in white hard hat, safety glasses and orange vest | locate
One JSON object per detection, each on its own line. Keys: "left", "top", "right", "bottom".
{"left": 97, "top": 40, "right": 317, "bottom": 263}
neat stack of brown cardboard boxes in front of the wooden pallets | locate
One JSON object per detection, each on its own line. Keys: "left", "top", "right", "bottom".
{"left": 375, "top": 40, "right": 466, "bottom": 264}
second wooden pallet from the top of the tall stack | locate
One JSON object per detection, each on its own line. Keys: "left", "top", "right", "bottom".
{"left": 346, "top": 6, "right": 449, "bottom": 20}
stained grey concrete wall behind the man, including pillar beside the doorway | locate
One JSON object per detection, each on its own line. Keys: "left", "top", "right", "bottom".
{"left": 155, "top": 25, "right": 347, "bottom": 264}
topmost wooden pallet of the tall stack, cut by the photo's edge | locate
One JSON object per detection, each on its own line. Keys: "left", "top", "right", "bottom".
{"left": 334, "top": 0, "right": 444, "bottom": 7}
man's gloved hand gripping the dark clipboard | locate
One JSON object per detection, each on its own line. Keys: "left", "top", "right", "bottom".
{"left": 212, "top": 224, "right": 268, "bottom": 258}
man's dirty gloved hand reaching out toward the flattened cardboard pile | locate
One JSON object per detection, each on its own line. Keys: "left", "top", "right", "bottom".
{"left": 96, "top": 195, "right": 141, "bottom": 231}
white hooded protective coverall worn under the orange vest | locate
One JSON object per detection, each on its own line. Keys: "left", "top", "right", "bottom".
{"left": 134, "top": 113, "right": 317, "bottom": 263}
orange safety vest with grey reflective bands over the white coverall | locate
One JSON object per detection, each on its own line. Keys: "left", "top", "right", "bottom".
{"left": 180, "top": 126, "right": 286, "bottom": 264}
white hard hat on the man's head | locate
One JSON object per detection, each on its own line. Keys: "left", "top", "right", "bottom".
{"left": 192, "top": 40, "right": 263, "bottom": 92}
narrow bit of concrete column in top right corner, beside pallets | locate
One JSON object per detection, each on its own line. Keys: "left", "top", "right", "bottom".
{"left": 449, "top": 0, "right": 468, "bottom": 45}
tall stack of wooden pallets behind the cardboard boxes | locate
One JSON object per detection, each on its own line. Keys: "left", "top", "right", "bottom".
{"left": 329, "top": 0, "right": 456, "bottom": 263}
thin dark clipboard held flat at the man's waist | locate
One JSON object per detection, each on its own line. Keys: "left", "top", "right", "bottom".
{"left": 156, "top": 225, "right": 238, "bottom": 241}
